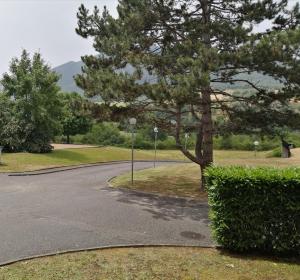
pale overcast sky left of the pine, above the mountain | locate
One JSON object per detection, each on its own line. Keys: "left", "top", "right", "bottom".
{"left": 0, "top": 0, "right": 118, "bottom": 74}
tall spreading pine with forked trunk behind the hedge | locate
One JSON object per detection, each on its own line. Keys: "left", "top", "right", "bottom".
{"left": 76, "top": 0, "right": 300, "bottom": 189}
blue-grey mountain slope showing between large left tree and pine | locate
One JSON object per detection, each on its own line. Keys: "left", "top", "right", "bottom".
{"left": 53, "top": 61, "right": 83, "bottom": 94}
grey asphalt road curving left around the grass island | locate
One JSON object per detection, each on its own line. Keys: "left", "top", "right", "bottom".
{"left": 0, "top": 162, "right": 212, "bottom": 263}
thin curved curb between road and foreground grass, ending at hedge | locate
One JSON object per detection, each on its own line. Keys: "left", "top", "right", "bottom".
{"left": 0, "top": 244, "right": 217, "bottom": 267}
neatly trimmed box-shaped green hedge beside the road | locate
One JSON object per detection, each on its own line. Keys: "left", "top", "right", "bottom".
{"left": 205, "top": 167, "right": 300, "bottom": 255}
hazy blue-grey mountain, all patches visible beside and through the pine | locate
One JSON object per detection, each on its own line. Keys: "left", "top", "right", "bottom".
{"left": 53, "top": 61, "right": 280, "bottom": 94}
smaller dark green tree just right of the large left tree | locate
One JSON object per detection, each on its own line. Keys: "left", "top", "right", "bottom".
{"left": 61, "top": 92, "right": 92, "bottom": 144}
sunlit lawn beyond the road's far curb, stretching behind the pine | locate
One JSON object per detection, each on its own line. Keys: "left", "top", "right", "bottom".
{"left": 0, "top": 144, "right": 300, "bottom": 172}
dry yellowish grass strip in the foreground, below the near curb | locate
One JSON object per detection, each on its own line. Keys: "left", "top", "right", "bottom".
{"left": 0, "top": 248, "right": 300, "bottom": 280}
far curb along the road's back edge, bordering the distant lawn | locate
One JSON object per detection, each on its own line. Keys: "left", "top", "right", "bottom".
{"left": 7, "top": 160, "right": 190, "bottom": 176}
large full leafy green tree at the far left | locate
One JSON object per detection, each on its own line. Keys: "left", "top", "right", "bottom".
{"left": 0, "top": 50, "right": 62, "bottom": 153}
